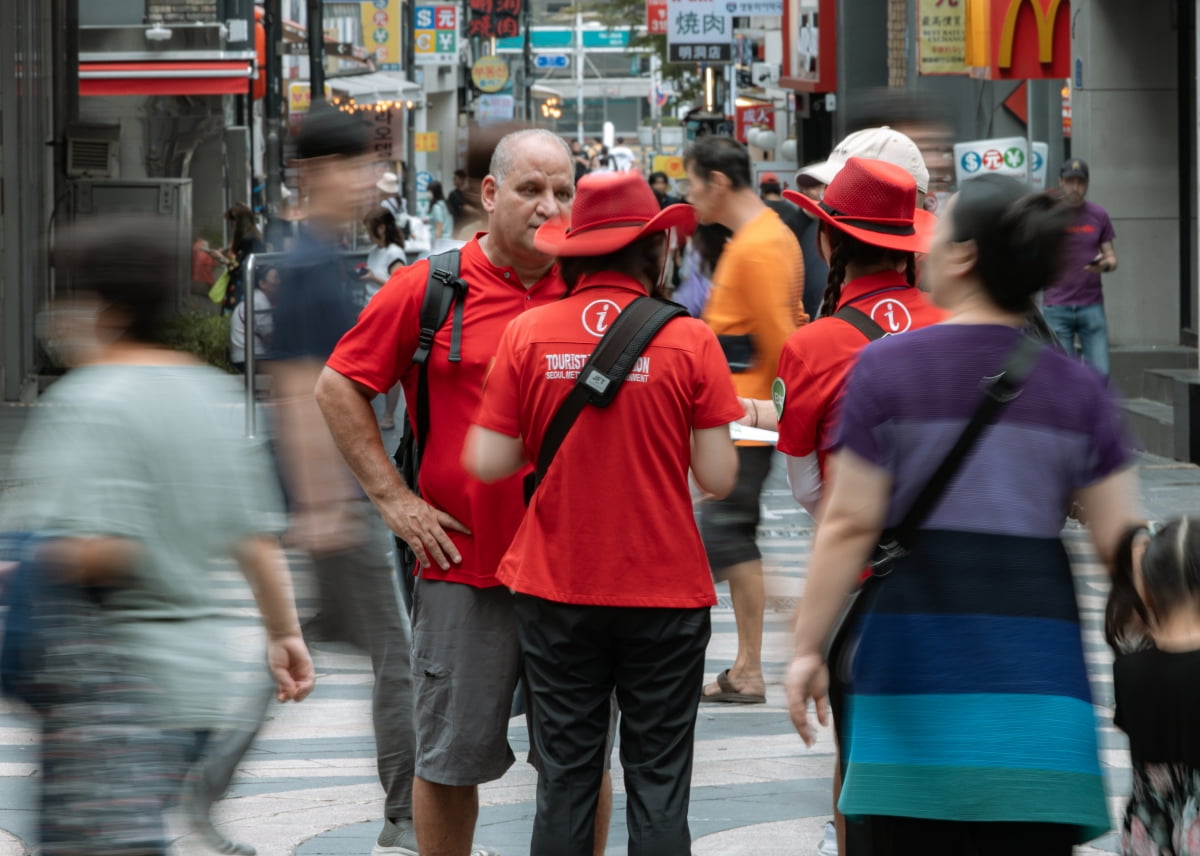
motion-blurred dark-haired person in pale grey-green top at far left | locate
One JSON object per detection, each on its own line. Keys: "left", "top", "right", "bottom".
{"left": 12, "top": 217, "right": 314, "bottom": 856}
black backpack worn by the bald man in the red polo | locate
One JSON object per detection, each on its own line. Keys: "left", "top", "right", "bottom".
{"left": 392, "top": 250, "right": 467, "bottom": 611}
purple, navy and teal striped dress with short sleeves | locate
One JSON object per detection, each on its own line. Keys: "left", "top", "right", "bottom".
{"left": 835, "top": 324, "right": 1129, "bottom": 842}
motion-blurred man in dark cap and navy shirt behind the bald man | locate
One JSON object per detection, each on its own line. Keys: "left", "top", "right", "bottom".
{"left": 271, "top": 103, "right": 416, "bottom": 856}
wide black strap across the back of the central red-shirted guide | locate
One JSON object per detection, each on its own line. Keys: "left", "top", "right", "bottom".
{"left": 526, "top": 298, "right": 688, "bottom": 504}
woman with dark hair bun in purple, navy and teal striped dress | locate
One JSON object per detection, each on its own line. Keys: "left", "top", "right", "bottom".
{"left": 786, "top": 171, "right": 1135, "bottom": 856}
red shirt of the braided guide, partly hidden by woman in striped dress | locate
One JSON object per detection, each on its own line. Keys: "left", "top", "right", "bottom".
{"left": 772, "top": 271, "right": 944, "bottom": 474}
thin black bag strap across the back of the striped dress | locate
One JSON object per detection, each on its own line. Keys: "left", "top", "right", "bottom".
{"left": 880, "top": 334, "right": 1045, "bottom": 559}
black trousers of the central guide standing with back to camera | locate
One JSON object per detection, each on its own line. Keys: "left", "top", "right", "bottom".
{"left": 514, "top": 594, "right": 710, "bottom": 856}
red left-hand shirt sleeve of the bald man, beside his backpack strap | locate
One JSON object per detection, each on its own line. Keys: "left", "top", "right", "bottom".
{"left": 326, "top": 263, "right": 430, "bottom": 394}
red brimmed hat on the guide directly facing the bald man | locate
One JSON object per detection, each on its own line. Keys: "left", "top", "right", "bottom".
{"left": 533, "top": 173, "right": 696, "bottom": 256}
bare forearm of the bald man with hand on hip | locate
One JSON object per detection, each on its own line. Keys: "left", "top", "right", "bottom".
{"left": 317, "top": 367, "right": 409, "bottom": 504}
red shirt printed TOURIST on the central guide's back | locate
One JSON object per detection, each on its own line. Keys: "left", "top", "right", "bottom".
{"left": 475, "top": 273, "right": 743, "bottom": 607}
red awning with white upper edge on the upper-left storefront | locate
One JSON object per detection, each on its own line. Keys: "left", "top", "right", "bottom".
{"left": 79, "top": 60, "right": 254, "bottom": 95}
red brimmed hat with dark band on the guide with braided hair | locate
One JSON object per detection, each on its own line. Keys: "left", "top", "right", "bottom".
{"left": 784, "top": 157, "right": 937, "bottom": 252}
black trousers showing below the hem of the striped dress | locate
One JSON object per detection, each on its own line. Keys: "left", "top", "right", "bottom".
{"left": 864, "top": 816, "right": 1076, "bottom": 856}
